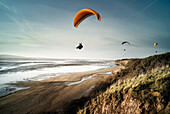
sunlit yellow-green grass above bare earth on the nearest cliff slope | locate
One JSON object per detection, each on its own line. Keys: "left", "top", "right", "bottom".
{"left": 78, "top": 65, "right": 170, "bottom": 114}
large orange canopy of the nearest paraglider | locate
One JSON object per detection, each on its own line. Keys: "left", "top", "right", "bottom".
{"left": 73, "top": 8, "right": 101, "bottom": 28}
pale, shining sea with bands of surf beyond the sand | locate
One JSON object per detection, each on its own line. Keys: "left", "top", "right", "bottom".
{"left": 0, "top": 58, "right": 115, "bottom": 97}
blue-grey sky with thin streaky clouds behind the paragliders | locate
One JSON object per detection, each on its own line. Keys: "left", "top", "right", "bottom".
{"left": 0, "top": 0, "right": 170, "bottom": 59}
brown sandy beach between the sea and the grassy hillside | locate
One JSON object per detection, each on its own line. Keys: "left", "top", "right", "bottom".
{"left": 0, "top": 62, "right": 124, "bottom": 113}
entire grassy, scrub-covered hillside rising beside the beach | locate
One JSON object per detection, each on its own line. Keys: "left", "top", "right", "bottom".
{"left": 66, "top": 52, "right": 170, "bottom": 114}
